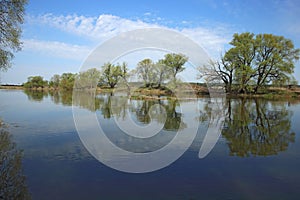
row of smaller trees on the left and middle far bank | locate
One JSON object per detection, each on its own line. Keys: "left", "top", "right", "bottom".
{"left": 23, "top": 53, "right": 188, "bottom": 90}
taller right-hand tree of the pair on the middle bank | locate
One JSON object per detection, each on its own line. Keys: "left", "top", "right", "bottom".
{"left": 163, "top": 53, "right": 188, "bottom": 80}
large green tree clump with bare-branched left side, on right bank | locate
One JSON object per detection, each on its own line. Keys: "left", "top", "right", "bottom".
{"left": 199, "top": 32, "right": 300, "bottom": 93}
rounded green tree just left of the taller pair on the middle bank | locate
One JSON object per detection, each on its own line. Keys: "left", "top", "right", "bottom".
{"left": 101, "top": 63, "right": 122, "bottom": 88}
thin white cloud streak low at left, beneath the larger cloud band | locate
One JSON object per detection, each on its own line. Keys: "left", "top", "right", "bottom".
{"left": 23, "top": 39, "right": 91, "bottom": 61}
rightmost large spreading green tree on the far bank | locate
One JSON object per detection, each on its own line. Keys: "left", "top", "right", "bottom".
{"left": 254, "top": 34, "right": 300, "bottom": 92}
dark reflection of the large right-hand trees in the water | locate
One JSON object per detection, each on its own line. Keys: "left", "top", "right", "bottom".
{"left": 222, "top": 99, "right": 295, "bottom": 157}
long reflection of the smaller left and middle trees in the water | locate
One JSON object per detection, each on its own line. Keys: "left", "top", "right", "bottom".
{"left": 26, "top": 90, "right": 186, "bottom": 130}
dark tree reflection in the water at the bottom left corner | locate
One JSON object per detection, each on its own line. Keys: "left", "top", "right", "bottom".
{"left": 0, "top": 121, "right": 31, "bottom": 200}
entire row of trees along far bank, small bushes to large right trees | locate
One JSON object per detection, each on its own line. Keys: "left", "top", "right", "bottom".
{"left": 24, "top": 32, "right": 300, "bottom": 93}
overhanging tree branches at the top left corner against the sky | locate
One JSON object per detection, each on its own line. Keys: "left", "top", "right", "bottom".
{"left": 0, "top": 0, "right": 27, "bottom": 70}
